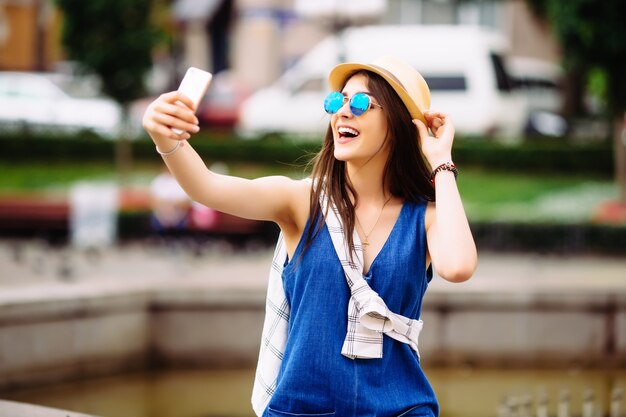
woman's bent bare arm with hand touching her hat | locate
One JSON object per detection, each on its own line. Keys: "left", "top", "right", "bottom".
{"left": 414, "top": 112, "right": 478, "bottom": 282}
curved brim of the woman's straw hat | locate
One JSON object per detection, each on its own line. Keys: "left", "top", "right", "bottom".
{"left": 328, "top": 63, "right": 426, "bottom": 124}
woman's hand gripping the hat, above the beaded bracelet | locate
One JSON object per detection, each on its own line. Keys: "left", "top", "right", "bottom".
{"left": 413, "top": 111, "right": 454, "bottom": 167}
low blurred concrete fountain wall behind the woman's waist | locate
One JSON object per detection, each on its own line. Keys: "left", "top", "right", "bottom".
{"left": 0, "top": 255, "right": 626, "bottom": 391}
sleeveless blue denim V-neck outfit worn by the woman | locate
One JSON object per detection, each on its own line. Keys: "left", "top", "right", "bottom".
{"left": 263, "top": 202, "right": 439, "bottom": 417}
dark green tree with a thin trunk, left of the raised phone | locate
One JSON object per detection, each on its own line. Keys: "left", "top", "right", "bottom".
{"left": 56, "top": 0, "right": 161, "bottom": 179}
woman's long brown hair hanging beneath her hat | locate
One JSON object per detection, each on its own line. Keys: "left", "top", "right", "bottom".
{"left": 305, "top": 70, "right": 435, "bottom": 253}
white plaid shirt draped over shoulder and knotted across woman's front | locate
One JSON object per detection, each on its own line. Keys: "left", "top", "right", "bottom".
{"left": 252, "top": 194, "right": 423, "bottom": 416}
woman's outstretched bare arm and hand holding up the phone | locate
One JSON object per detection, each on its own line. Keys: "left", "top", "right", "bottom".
{"left": 143, "top": 91, "right": 308, "bottom": 228}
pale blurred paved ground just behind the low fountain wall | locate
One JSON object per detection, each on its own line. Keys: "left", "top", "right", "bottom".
{"left": 0, "top": 237, "right": 626, "bottom": 300}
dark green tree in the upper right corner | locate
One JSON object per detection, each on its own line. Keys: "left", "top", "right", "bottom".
{"left": 526, "top": 0, "right": 626, "bottom": 203}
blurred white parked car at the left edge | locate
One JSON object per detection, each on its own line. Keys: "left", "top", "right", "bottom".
{"left": 0, "top": 72, "right": 122, "bottom": 138}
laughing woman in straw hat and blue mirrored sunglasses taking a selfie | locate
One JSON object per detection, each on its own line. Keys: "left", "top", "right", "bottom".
{"left": 143, "top": 57, "right": 477, "bottom": 417}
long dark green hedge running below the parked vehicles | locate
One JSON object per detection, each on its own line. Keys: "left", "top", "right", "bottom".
{"left": 0, "top": 133, "right": 614, "bottom": 177}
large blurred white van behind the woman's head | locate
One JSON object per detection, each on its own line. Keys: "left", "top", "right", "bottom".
{"left": 237, "top": 26, "right": 527, "bottom": 138}
